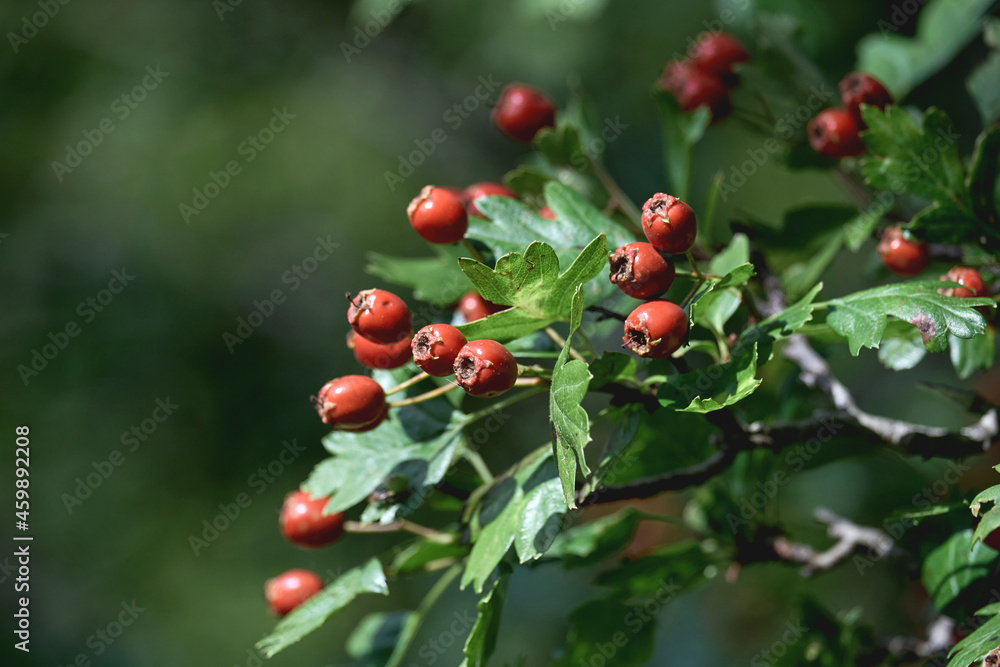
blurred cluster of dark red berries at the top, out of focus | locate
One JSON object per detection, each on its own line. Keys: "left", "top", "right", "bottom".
{"left": 660, "top": 32, "right": 749, "bottom": 122}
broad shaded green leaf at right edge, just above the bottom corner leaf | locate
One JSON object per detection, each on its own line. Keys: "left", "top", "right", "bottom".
{"left": 921, "top": 530, "right": 1000, "bottom": 612}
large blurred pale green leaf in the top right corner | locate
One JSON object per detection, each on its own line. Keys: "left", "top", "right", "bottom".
{"left": 855, "top": 0, "right": 992, "bottom": 99}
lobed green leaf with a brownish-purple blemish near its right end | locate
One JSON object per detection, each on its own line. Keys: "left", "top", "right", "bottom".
{"left": 827, "top": 280, "right": 993, "bottom": 356}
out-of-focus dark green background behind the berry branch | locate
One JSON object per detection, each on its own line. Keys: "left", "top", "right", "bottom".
{"left": 0, "top": 0, "right": 1000, "bottom": 667}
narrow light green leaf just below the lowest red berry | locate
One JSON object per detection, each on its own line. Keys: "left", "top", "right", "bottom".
{"left": 256, "top": 558, "right": 389, "bottom": 658}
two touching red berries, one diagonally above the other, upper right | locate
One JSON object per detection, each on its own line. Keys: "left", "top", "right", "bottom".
{"left": 808, "top": 72, "right": 892, "bottom": 159}
